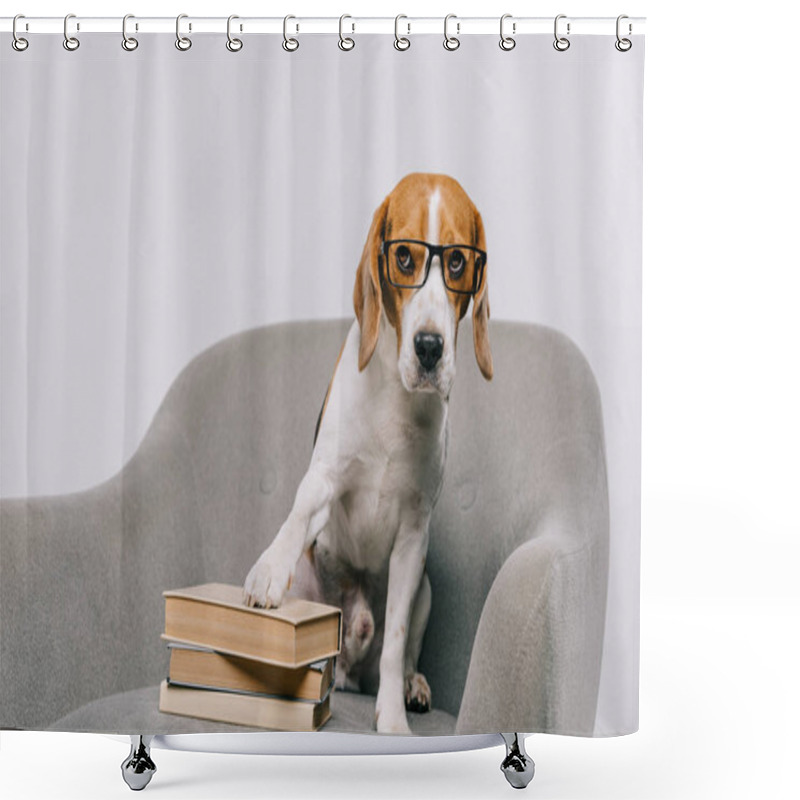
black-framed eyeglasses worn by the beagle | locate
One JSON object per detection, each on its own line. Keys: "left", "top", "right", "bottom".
{"left": 381, "top": 239, "right": 486, "bottom": 295}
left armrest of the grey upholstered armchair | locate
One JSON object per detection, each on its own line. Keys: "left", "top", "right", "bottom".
{"left": 0, "top": 480, "right": 122, "bottom": 729}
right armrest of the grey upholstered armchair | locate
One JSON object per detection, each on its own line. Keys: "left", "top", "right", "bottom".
{"left": 456, "top": 519, "right": 608, "bottom": 736}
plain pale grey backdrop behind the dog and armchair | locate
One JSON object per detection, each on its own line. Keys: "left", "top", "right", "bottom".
{"left": 0, "top": 34, "right": 644, "bottom": 734}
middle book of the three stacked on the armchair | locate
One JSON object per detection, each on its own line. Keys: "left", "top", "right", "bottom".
{"left": 168, "top": 642, "right": 334, "bottom": 702}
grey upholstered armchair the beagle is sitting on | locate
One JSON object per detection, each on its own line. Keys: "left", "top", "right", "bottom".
{"left": 0, "top": 320, "right": 609, "bottom": 735}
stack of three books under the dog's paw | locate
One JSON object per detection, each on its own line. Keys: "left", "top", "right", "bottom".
{"left": 159, "top": 583, "right": 342, "bottom": 731}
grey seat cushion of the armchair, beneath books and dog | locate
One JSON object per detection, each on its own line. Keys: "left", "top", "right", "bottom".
{"left": 47, "top": 686, "right": 456, "bottom": 736}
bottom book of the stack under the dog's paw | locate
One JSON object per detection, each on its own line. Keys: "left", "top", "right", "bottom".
{"left": 158, "top": 680, "right": 331, "bottom": 731}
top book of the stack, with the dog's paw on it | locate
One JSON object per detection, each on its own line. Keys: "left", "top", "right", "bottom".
{"left": 162, "top": 583, "right": 342, "bottom": 669}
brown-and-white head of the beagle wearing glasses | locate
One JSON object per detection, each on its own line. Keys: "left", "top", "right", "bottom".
{"left": 353, "top": 173, "right": 492, "bottom": 397}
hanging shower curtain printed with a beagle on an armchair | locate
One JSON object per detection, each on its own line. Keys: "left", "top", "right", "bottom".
{"left": 0, "top": 22, "right": 644, "bottom": 736}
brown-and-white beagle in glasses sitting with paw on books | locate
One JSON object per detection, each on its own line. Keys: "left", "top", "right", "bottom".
{"left": 243, "top": 173, "right": 492, "bottom": 733}
